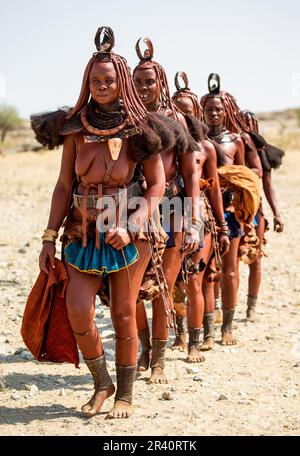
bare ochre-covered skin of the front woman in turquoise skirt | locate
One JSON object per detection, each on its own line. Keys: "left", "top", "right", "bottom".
{"left": 40, "top": 52, "right": 165, "bottom": 418}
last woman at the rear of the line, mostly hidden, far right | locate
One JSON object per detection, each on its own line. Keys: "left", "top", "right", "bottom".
{"left": 243, "top": 111, "right": 284, "bottom": 321}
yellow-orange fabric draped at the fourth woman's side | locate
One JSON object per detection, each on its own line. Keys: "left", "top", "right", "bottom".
{"left": 218, "top": 165, "right": 260, "bottom": 223}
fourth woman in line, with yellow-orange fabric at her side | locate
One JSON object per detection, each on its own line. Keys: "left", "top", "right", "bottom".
{"left": 201, "top": 74, "right": 256, "bottom": 345}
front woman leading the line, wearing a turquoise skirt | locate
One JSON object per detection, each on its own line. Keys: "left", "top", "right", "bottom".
{"left": 32, "top": 27, "right": 186, "bottom": 418}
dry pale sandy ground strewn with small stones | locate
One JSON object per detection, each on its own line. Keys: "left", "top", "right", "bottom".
{"left": 0, "top": 151, "right": 300, "bottom": 436}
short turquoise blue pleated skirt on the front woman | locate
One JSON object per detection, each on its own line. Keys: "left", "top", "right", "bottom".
{"left": 64, "top": 233, "right": 139, "bottom": 276}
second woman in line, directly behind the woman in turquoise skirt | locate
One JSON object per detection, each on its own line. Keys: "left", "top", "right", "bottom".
{"left": 133, "top": 38, "right": 201, "bottom": 383}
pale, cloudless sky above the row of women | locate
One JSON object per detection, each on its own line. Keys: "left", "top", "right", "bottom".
{"left": 0, "top": 0, "right": 300, "bottom": 117}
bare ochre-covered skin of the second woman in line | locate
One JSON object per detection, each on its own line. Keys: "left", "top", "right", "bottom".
{"left": 134, "top": 57, "right": 199, "bottom": 383}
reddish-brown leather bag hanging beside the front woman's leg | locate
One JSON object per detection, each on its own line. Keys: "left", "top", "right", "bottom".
{"left": 21, "top": 258, "right": 79, "bottom": 367}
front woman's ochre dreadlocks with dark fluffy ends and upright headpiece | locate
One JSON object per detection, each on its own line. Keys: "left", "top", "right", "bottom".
{"left": 31, "top": 27, "right": 195, "bottom": 162}
